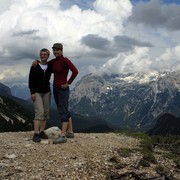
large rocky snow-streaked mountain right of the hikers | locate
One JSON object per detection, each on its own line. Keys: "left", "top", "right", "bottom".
{"left": 70, "top": 72, "right": 180, "bottom": 131}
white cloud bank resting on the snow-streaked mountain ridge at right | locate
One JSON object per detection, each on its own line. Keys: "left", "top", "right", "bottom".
{"left": 93, "top": 46, "right": 180, "bottom": 74}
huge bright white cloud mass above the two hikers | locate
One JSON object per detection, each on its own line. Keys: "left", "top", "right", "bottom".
{"left": 0, "top": 0, "right": 132, "bottom": 84}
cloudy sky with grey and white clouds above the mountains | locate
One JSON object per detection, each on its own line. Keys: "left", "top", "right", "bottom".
{"left": 0, "top": 0, "right": 180, "bottom": 85}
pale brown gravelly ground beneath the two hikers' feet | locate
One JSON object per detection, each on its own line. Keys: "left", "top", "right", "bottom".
{"left": 0, "top": 128, "right": 180, "bottom": 180}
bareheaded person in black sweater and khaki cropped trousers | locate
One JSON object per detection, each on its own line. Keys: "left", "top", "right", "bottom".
{"left": 29, "top": 48, "right": 52, "bottom": 142}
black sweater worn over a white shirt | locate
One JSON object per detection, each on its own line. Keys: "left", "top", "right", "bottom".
{"left": 29, "top": 63, "right": 52, "bottom": 94}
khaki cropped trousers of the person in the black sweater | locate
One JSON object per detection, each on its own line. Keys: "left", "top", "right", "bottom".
{"left": 33, "top": 92, "right": 51, "bottom": 121}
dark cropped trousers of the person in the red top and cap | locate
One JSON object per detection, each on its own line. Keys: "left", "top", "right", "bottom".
{"left": 53, "top": 87, "right": 70, "bottom": 123}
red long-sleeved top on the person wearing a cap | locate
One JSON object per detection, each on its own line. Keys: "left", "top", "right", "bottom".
{"left": 49, "top": 55, "right": 78, "bottom": 88}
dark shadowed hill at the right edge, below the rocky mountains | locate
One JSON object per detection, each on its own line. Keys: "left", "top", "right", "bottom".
{"left": 147, "top": 114, "right": 180, "bottom": 136}
